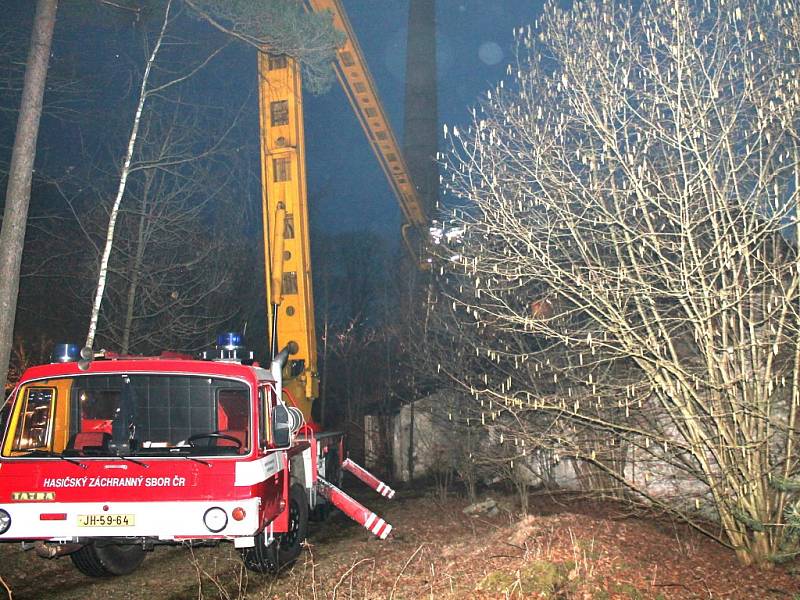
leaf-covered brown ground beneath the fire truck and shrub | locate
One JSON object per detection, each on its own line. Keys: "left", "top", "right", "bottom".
{"left": 0, "top": 490, "right": 800, "bottom": 600}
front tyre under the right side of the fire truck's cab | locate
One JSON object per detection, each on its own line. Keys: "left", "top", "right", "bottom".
{"left": 240, "top": 483, "right": 308, "bottom": 575}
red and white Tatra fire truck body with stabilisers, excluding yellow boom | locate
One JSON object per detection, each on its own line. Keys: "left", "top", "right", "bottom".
{"left": 0, "top": 334, "right": 394, "bottom": 577}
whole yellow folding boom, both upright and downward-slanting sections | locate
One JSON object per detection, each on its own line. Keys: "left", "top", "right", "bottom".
{"left": 258, "top": 0, "right": 428, "bottom": 423}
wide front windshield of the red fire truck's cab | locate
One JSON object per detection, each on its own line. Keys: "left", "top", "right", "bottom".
{"left": 2, "top": 374, "right": 251, "bottom": 457}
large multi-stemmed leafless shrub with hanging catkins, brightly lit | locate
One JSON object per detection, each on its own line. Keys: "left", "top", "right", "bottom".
{"left": 439, "top": 0, "right": 800, "bottom": 565}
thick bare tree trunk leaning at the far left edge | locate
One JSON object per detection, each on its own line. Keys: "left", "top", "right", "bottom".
{"left": 0, "top": 0, "right": 58, "bottom": 389}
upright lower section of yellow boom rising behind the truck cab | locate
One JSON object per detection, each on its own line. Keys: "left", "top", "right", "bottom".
{"left": 258, "top": 52, "right": 319, "bottom": 422}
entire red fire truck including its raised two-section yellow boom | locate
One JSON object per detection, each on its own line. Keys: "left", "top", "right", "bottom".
{"left": 0, "top": 0, "right": 427, "bottom": 576}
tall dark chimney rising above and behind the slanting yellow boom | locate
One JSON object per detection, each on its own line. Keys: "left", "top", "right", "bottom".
{"left": 403, "top": 0, "right": 439, "bottom": 217}
